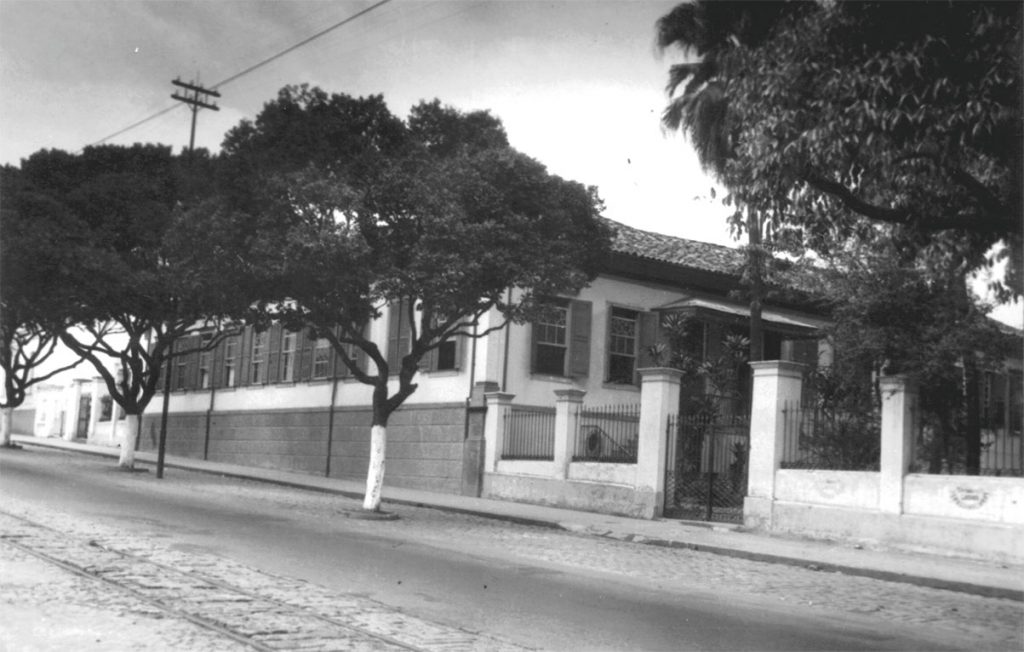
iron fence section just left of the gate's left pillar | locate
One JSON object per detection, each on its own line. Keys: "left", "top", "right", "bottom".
{"left": 572, "top": 404, "right": 640, "bottom": 464}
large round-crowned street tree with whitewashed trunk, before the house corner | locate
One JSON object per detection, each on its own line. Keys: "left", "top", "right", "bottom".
{"left": 217, "top": 86, "right": 610, "bottom": 511}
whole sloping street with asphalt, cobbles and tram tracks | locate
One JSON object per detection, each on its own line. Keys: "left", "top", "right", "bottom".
{"left": 0, "top": 446, "right": 1022, "bottom": 650}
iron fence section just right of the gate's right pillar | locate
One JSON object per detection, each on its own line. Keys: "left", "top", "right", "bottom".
{"left": 780, "top": 401, "right": 882, "bottom": 471}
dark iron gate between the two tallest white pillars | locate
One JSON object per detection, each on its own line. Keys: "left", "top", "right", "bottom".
{"left": 664, "top": 415, "right": 751, "bottom": 523}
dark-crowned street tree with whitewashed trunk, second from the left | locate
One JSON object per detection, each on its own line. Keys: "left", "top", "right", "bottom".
{"left": 22, "top": 144, "right": 248, "bottom": 469}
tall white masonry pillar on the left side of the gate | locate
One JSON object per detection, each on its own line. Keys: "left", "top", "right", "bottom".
{"left": 637, "top": 367, "right": 683, "bottom": 518}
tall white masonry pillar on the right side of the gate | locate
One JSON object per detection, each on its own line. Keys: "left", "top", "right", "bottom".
{"left": 743, "top": 360, "right": 804, "bottom": 529}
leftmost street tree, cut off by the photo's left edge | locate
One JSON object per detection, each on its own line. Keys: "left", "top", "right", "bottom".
{"left": 0, "top": 166, "right": 81, "bottom": 447}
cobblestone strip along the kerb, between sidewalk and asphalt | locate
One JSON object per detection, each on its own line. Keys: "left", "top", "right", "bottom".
{"left": 165, "top": 470, "right": 1024, "bottom": 650}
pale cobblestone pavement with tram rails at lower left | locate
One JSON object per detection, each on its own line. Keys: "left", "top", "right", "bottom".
{"left": 0, "top": 508, "right": 522, "bottom": 652}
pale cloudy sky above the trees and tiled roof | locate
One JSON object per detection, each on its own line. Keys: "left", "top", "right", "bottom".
{"left": 0, "top": 0, "right": 1024, "bottom": 327}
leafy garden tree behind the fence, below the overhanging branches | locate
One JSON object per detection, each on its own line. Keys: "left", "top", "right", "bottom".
{"left": 808, "top": 242, "right": 1020, "bottom": 474}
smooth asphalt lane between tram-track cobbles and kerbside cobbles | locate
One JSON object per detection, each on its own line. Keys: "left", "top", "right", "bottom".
{"left": 0, "top": 448, "right": 999, "bottom": 650}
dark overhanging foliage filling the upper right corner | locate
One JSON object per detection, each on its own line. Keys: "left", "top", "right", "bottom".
{"left": 658, "top": 1, "right": 1022, "bottom": 292}
